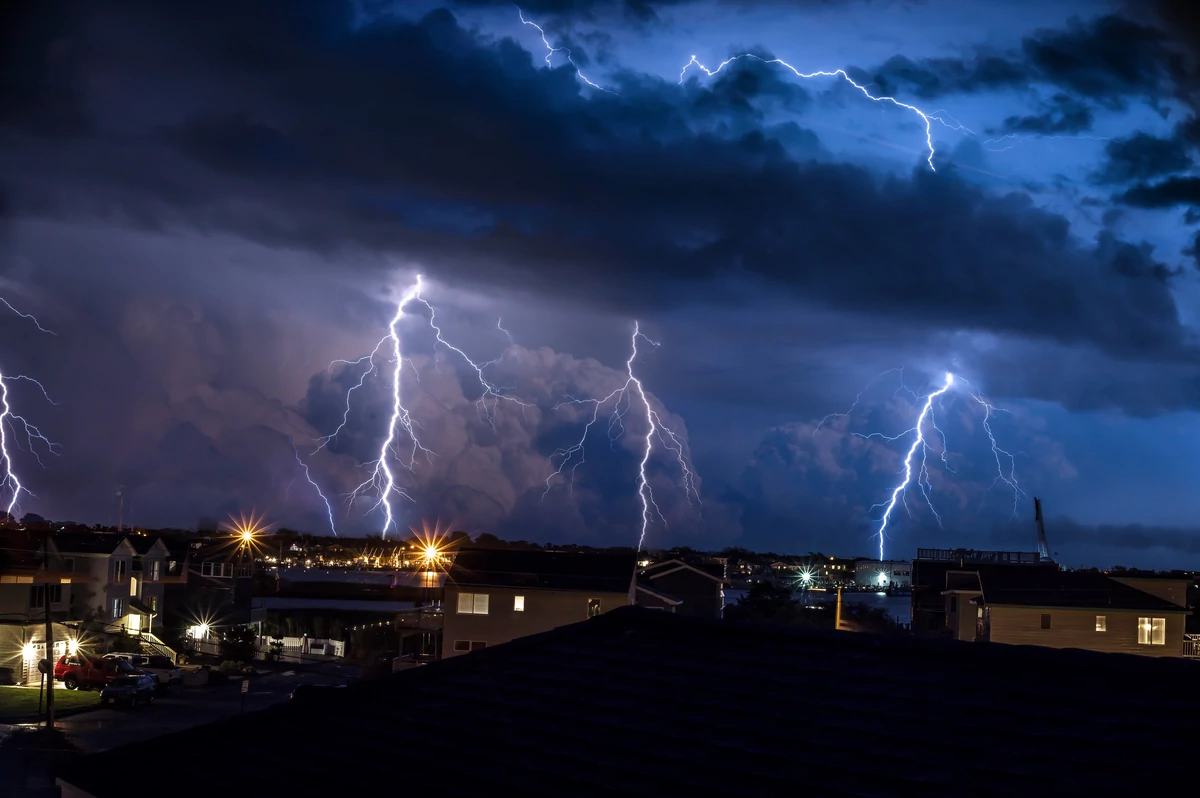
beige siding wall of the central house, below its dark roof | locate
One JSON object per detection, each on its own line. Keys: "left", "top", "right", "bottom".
{"left": 442, "top": 584, "right": 629, "bottom": 659}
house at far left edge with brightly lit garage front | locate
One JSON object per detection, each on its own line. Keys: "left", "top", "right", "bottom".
{"left": 0, "top": 528, "right": 79, "bottom": 684}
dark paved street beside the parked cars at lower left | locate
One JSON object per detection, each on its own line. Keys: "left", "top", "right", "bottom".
{"left": 0, "top": 668, "right": 355, "bottom": 752}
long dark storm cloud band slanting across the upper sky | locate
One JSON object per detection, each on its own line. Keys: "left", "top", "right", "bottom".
{"left": 2, "top": 2, "right": 1187, "bottom": 367}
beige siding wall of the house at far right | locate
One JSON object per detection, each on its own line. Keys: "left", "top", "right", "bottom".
{"left": 988, "top": 605, "right": 1186, "bottom": 656}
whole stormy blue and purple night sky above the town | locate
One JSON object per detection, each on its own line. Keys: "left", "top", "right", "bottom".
{"left": 0, "top": 0, "right": 1200, "bottom": 568}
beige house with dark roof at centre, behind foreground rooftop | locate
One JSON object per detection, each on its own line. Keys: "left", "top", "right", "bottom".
{"left": 442, "top": 550, "right": 636, "bottom": 659}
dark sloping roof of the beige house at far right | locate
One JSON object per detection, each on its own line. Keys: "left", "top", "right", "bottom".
{"left": 979, "top": 566, "right": 1187, "bottom": 612}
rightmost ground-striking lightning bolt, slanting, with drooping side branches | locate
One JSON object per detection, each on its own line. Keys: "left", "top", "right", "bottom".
{"left": 830, "top": 368, "right": 1025, "bottom": 560}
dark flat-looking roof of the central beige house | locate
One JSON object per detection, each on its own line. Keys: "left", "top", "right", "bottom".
{"left": 446, "top": 550, "right": 636, "bottom": 593}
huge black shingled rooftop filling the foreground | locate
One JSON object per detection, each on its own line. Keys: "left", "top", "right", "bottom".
{"left": 65, "top": 607, "right": 1200, "bottom": 798}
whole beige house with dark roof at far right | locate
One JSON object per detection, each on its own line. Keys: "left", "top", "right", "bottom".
{"left": 943, "top": 568, "right": 1189, "bottom": 656}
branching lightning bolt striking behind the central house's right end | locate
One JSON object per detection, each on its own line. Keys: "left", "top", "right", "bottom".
{"left": 542, "top": 322, "right": 700, "bottom": 551}
